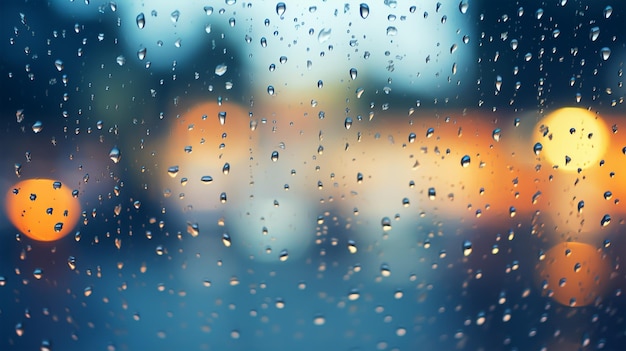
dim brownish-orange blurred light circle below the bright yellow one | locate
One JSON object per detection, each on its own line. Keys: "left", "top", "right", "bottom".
{"left": 537, "top": 242, "right": 610, "bottom": 307}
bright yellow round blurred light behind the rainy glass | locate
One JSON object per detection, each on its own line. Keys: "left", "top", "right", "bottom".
{"left": 533, "top": 107, "right": 609, "bottom": 171}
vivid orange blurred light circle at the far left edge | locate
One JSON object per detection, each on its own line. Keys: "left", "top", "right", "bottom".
{"left": 6, "top": 179, "right": 80, "bottom": 241}
